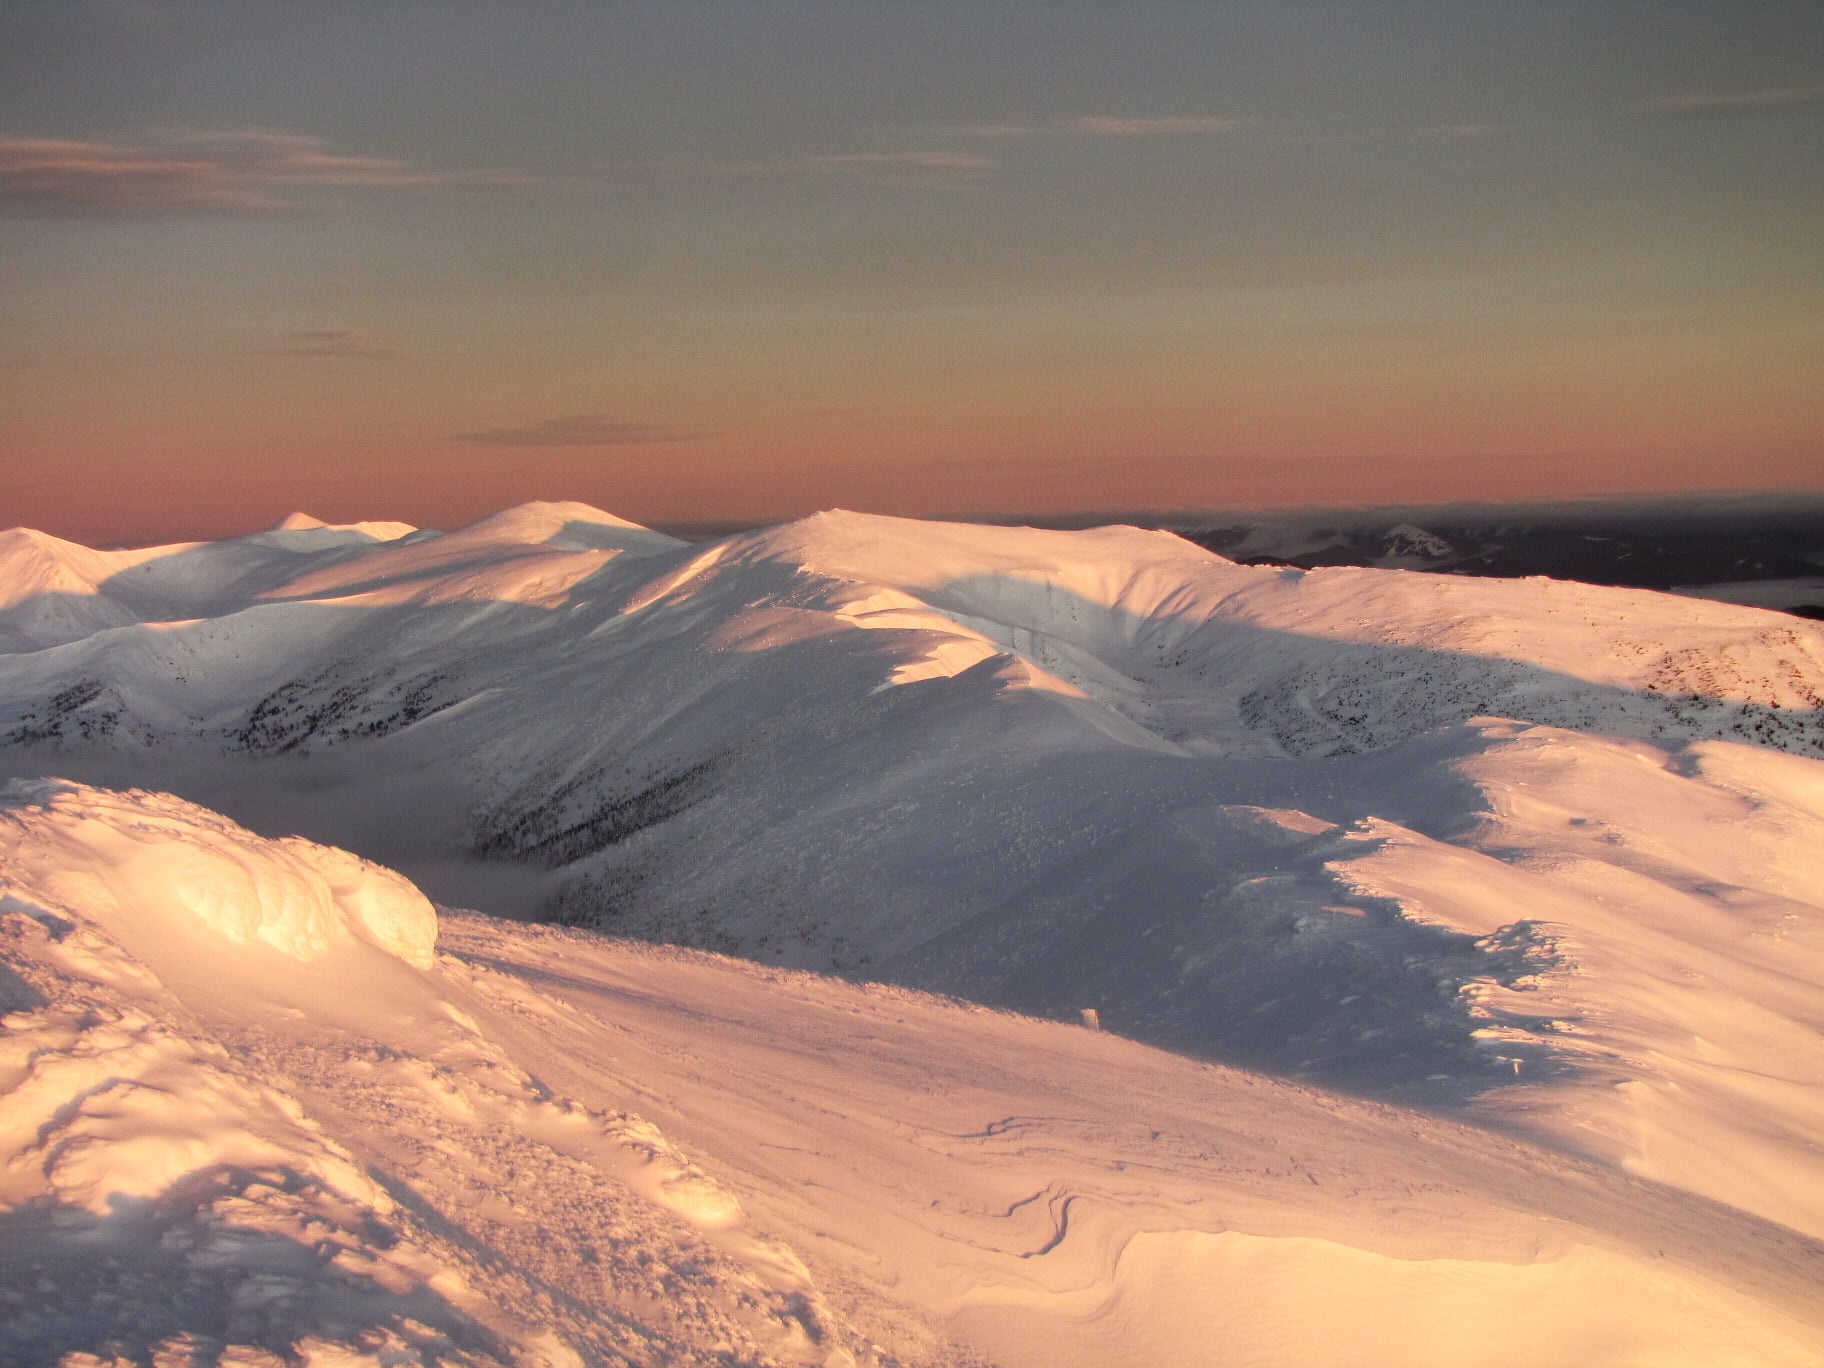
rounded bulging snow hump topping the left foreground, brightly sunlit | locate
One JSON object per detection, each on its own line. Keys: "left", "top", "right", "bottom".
{"left": 0, "top": 779, "right": 438, "bottom": 969}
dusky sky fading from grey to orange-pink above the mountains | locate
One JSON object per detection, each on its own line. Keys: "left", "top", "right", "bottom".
{"left": 0, "top": 0, "right": 1824, "bottom": 542}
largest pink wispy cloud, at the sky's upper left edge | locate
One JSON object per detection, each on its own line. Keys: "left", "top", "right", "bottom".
{"left": 0, "top": 130, "right": 525, "bottom": 219}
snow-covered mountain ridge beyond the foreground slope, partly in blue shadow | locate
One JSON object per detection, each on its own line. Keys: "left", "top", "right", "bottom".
{"left": 0, "top": 505, "right": 1824, "bottom": 1262}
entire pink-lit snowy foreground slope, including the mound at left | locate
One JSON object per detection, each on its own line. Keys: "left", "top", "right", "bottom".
{"left": 0, "top": 781, "right": 1824, "bottom": 1368}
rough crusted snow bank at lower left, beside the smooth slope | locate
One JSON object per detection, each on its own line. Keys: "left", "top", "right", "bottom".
{"left": 0, "top": 781, "right": 958, "bottom": 1368}
